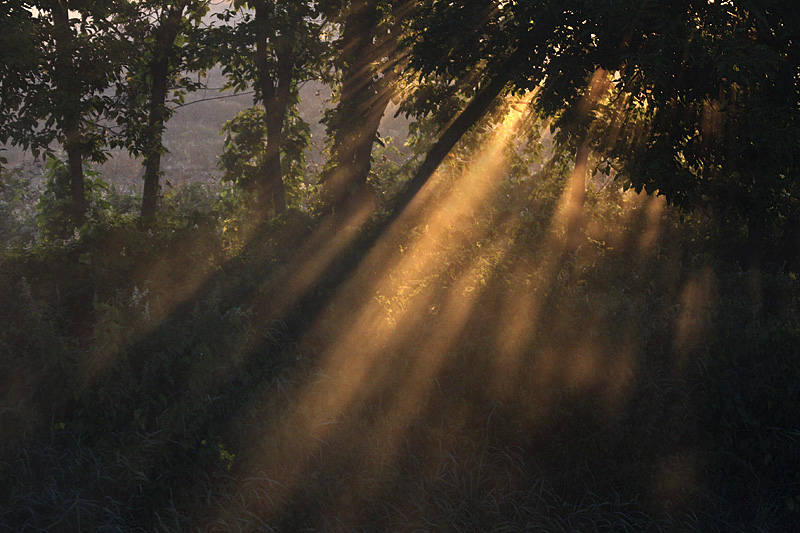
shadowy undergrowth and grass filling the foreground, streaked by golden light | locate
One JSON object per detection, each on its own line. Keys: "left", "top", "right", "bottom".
{"left": 0, "top": 159, "right": 800, "bottom": 531}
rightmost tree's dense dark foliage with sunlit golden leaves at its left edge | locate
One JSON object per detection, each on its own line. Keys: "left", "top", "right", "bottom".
{"left": 593, "top": 0, "right": 800, "bottom": 263}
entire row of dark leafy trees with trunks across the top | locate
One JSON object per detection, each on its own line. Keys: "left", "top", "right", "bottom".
{"left": 0, "top": 0, "right": 800, "bottom": 247}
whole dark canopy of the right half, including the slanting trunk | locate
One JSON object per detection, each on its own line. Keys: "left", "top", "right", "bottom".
{"left": 409, "top": 0, "right": 800, "bottom": 262}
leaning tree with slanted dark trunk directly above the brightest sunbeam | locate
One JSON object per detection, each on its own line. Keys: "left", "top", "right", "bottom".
{"left": 395, "top": 0, "right": 559, "bottom": 210}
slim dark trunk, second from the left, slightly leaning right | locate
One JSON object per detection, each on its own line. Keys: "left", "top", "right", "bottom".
{"left": 141, "top": 5, "right": 183, "bottom": 223}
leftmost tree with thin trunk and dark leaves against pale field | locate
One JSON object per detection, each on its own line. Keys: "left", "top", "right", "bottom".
{"left": 0, "top": 0, "right": 125, "bottom": 224}
